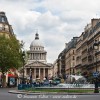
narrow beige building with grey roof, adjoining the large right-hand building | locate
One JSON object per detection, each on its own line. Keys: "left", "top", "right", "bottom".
{"left": 65, "top": 37, "right": 78, "bottom": 75}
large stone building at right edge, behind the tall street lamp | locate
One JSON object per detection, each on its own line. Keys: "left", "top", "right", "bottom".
{"left": 75, "top": 19, "right": 100, "bottom": 76}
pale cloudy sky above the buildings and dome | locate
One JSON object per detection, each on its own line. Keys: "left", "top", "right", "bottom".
{"left": 0, "top": 0, "right": 100, "bottom": 63}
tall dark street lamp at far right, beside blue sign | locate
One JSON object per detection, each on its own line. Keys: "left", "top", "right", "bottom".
{"left": 93, "top": 41, "right": 99, "bottom": 93}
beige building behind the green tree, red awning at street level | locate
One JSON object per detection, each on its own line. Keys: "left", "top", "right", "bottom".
{"left": 0, "top": 12, "right": 18, "bottom": 86}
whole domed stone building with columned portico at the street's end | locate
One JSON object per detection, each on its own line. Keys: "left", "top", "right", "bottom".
{"left": 25, "top": 33, "right": 53, "bottom": 79}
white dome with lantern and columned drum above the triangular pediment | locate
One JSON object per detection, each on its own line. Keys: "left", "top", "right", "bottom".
{"left": 28, "top": 33, "right": 47, "bottom": 63}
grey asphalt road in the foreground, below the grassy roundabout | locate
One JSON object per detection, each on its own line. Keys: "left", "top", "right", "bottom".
{"left": 0, "top": 88, "right": 100, "bottom": 100}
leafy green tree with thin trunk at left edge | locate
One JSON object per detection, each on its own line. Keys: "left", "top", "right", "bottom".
{"left": 0, "top": 35, "right": 23, "bottom": 84}
